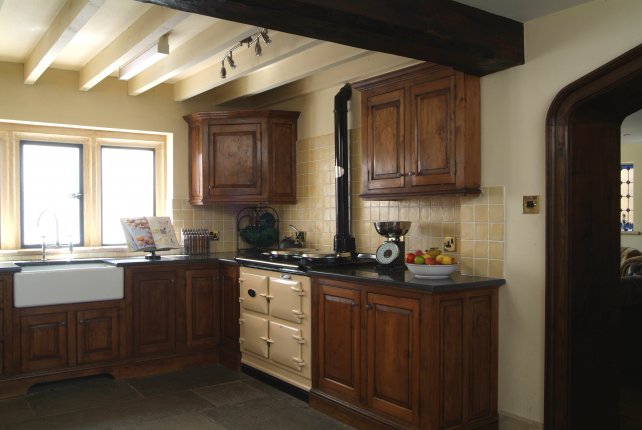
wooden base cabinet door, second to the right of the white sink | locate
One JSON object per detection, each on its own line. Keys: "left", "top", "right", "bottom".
{"left": 185, "top": 270, "right": 220, "bottom": 348}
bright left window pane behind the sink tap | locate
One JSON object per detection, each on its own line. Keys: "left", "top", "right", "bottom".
{"left": 21, "top": 142, "right": 82, "bottom": 246}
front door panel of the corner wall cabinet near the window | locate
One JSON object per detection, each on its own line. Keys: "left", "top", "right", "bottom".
{"left": 205, "top": 123, "right": 262, "bottom": 197}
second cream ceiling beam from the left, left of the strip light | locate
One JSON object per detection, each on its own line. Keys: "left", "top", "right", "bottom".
{"left": 79, "top": 6, "right": 189, "bottom": 91}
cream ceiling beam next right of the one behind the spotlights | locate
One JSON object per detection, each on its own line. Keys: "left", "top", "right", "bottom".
{"left": 202, "top": 42, "right": 371, "bottom": 105}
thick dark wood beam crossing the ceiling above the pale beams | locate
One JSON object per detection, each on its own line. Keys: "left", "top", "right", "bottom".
{"left": 138, "top": 0, "right": 524, "bottom": 76}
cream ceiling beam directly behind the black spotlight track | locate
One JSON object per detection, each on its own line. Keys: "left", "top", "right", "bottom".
{"left": 174, "top": 33, "right": 323, "bottom": 101}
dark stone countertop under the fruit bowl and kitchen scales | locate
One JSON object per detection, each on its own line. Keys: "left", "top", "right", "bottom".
{"left": 308, "top": 266, "right": 506, "bottom": 292}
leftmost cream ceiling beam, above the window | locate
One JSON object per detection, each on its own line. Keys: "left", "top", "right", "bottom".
{"left": 24, "top": 0, "right": 105, "bottom": 85}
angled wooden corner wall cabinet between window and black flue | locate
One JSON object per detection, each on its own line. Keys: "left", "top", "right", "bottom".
{"left": 184, "top": 110, "right": 299, "bottom": 205}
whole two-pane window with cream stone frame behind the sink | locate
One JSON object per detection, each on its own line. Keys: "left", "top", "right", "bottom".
{"left": 0, "top": 122, "right": 165, "bottom": 250}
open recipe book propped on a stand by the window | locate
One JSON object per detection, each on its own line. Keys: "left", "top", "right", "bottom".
{"left": 120, "top": 216, "right": 180, "bottom": 251}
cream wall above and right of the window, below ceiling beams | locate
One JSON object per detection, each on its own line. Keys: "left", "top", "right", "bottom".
{"left": 0, "top": 63, "right": 209, "bottom": 201}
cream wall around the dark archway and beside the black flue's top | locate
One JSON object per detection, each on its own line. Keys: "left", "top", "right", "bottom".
{"left": 266, "top": 0, "right": 642, "bottom": 423}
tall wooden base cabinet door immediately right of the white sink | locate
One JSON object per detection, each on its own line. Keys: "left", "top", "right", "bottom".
{"left": 133, "top": 271, "right": 176, "bottom": 356}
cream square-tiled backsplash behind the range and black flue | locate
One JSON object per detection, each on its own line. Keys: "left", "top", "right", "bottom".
{"left": 173, "top": 130, "right": 505, "bottom": 277}
